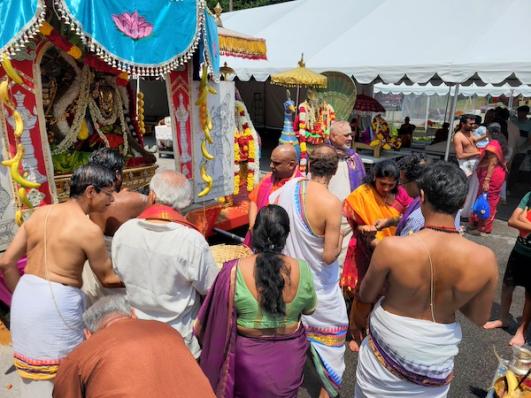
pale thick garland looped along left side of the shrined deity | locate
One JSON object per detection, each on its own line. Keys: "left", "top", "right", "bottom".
{"left": 52, "top": 66, "right": 92, "bottom": 155}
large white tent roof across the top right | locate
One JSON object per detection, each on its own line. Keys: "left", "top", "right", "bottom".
{"left": 223, "top": 0, "right": 531, "bottom": 86}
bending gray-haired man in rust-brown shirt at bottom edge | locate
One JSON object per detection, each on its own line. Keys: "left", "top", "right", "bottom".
{"left": 53, "top": 295, "right": 214, "bottom": 398}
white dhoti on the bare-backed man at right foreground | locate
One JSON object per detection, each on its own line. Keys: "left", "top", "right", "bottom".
{"left": 355, "top": 300, "right": 462, "bottom": 398}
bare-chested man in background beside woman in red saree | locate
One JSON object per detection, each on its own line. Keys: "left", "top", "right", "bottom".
{"left": 453, "top": 115, "right": 485, "bottom": 218}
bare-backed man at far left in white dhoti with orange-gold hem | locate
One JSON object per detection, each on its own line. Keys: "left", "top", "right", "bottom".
{"left": 0, "top": 165, "right": 121, "bottom": 397}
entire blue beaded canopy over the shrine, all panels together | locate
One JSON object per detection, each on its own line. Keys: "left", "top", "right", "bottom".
{"left": 0, "top": 0, "right": 219, "bottom": 76}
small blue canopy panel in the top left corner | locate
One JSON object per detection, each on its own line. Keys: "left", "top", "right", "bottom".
{"left": 0, "top": 0, "right": 45, "bottom": 55}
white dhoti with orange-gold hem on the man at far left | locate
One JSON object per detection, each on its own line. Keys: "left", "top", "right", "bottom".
{"left": 11, "top": 274, "right": 85, "bottom": 380}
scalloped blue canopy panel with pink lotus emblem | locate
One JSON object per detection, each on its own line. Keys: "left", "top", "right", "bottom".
{"left": 55, "top": 0, "right": 219, "bottom": 75}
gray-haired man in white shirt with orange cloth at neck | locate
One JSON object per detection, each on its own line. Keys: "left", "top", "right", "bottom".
{"left": 112, "top": 170, "right": 218, "bottom": 358}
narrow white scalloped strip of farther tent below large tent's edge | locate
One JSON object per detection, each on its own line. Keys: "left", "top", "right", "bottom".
{"left": 374, "top": 83, "right": 531, "bottom": 97}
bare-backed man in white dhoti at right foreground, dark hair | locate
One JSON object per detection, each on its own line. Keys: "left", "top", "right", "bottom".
{"left": 354, "top": 162, "right": 498, "bottom": 398}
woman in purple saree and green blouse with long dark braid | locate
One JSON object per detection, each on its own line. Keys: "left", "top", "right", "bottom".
{"left": 194, "top": 205, "right": 316, "bottom": 398}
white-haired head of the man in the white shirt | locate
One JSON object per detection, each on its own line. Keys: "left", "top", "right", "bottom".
{"left": 149, "top": 170, "right": 192, "bottom": 210}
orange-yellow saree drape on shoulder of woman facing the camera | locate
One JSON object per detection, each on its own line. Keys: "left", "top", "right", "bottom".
{"left": 344, "top": 184, "right": 400, "bottom": 239}
